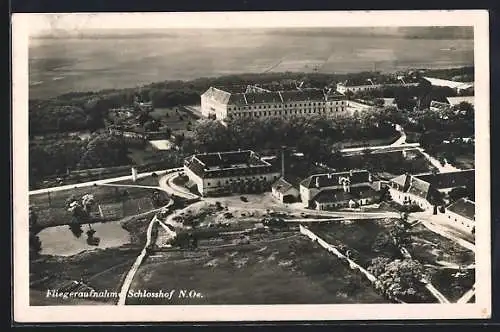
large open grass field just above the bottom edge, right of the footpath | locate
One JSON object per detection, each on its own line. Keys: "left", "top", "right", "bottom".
{"left": 127, "top": 236, "right": 387, "bottom": 304}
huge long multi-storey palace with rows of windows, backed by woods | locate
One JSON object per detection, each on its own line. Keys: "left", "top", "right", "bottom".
{"left": 201, "top": 86, "right": 347, "bottom": 120}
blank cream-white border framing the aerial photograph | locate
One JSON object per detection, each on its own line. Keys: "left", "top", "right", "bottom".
{"left": 12, "top": 10, "right": 491, "bottom": 322}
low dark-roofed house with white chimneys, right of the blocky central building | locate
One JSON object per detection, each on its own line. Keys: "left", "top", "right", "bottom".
{"left": 300, "top": 170, "right": 379, "bottom": 209}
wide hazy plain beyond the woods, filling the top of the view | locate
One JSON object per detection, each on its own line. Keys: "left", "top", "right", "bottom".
{"left": 29, "top": 29, "right": 474, "bottom": 98}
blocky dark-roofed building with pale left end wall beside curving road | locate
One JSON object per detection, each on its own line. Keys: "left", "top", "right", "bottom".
{"left": 184, "top": 150, "right": 281, "bottom": 196}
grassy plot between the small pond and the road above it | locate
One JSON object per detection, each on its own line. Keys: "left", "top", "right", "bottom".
{"left": 30, "top": 186, "right": 166, "bottom": 227}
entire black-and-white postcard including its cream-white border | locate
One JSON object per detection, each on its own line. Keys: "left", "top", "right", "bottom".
{"left": 13, "top": 11, "right": 491, "bottom": 322}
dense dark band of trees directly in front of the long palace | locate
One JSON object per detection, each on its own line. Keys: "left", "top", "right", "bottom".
{"left": 186, "top": 110, "right": 399, "bottom": 160}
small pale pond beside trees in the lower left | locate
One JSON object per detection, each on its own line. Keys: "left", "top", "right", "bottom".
{"left": 38, "top": 221, "right": 130, "bottom": 256}
